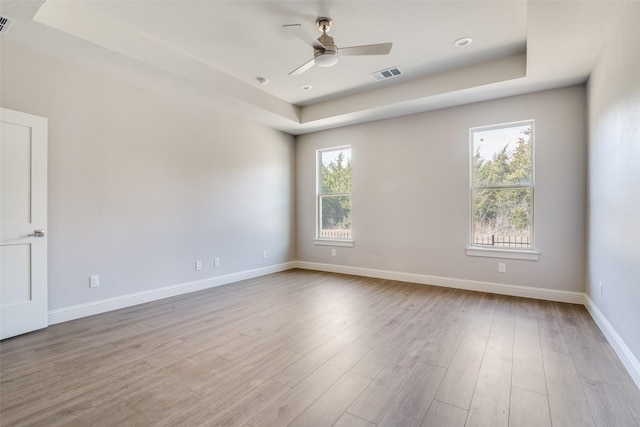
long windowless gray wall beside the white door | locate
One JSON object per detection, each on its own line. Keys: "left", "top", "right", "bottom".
{"left": 1, "top": 42, "right": 295, "bottom": 310}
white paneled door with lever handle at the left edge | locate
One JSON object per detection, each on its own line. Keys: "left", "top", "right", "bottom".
{"left": 0, "top": 108, "right": 48, "bottom": 339}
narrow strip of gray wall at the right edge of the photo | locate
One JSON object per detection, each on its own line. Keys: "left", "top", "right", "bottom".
{"left": 586, "top": 2, "right": 640, "bottom": 360}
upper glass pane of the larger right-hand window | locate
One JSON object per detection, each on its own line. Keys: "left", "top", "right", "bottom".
{"left": 473, "top": 125, "right": 532, "bottom": 188}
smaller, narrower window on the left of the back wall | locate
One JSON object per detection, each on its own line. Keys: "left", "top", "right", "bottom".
{"left": 316, "top": 146, "right": 351, "bottom": 244}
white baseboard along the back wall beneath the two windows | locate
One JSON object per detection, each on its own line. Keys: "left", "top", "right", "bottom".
{"left": 295, "top": 261, "right": 585, "bottom": 304}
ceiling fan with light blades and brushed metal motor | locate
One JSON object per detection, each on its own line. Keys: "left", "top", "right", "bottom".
{"left": 282, "top": 16, "right": 393, "bottom": 76}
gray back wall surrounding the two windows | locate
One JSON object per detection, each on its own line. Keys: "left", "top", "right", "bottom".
{"left": 296, "top": 86, "right": 587, "bottom": 292}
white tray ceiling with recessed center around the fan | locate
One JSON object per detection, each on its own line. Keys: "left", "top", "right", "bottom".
{"left": 0, "top": 0, "right": 632, "bottom": 134}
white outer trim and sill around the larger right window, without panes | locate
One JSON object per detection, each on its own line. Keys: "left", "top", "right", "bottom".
{"left": 466, "top": 119, "right": 540, "bottom": 261}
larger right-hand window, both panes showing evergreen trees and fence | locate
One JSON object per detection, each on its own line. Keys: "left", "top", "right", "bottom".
{"left": 467, "top": 121, "right": 534, "bottom": 255}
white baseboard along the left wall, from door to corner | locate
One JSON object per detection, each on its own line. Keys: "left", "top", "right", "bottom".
{"left": 49, "top": 262, "right": 295, "bottom": 325}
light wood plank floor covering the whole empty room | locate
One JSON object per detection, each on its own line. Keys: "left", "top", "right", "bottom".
{"left": 0, "top": 270, "right": 640, "bottom": 427}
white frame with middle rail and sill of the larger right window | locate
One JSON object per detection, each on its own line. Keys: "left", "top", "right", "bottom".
{"left": 466, "top": 119, "right": 540, "bottom": 261}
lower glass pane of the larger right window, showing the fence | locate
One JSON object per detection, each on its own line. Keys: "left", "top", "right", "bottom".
{"left": 473, "top": 188, "right": 533, "bottom": 249}
